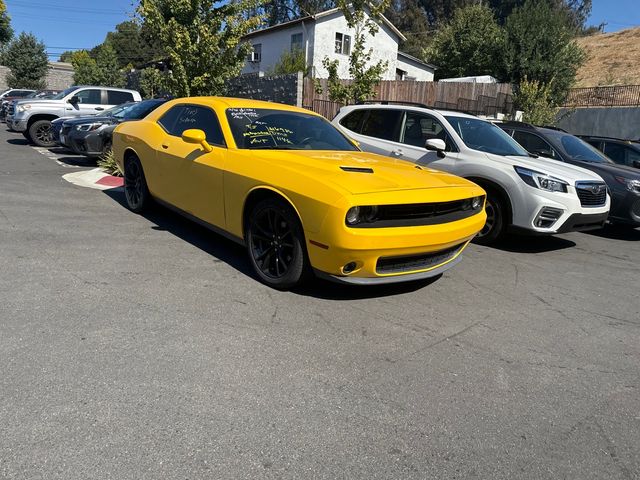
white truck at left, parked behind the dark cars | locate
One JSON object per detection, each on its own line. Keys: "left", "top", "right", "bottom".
{"left": 10, "top": 86, "right": 141, "bottom": 147}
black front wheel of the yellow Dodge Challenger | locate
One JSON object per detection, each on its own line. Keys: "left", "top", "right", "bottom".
{"left": 245, "top": 198, "right": 310, "bottom": 290}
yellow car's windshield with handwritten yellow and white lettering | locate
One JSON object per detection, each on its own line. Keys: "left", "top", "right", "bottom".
{"left": 227, "top": 108, "right": 357, "bottom": 151}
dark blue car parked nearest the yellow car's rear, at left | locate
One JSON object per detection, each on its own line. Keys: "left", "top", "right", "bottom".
{"left": 60, "top": 99, "right": 166, "bottom": 157}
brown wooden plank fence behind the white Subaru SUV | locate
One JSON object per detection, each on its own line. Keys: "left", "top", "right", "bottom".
{"left": 303, "top": 78, "right": 513, "bottom": 119}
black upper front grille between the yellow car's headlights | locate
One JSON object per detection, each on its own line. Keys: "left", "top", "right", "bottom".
{"left": 350, "top": 198, "right": 484, "bottom": 228}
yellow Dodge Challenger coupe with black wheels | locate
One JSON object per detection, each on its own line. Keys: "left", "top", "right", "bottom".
{"left": 113, "top": 97, "right": 486, "bottom": 289}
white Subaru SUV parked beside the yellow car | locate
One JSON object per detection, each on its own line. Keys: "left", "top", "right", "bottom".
{"left": 333, "top": 104, "right": 610, "bottom": 244}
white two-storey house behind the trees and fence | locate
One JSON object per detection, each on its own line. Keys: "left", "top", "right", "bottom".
{"left": 242, "top": 8, "right": 436, "bottom": 81}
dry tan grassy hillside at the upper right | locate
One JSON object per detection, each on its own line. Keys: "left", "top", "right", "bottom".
{"left": 576, "top": 27, "right": 640, "bottom": 87}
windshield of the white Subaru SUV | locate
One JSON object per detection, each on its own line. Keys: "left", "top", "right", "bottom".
{"left": 445, "top": 115, "right": 529, "bottom": 157}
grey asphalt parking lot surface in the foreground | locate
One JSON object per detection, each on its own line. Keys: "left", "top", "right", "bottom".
{"left": 0, "top": 128, "right": 640, "bottom": 480}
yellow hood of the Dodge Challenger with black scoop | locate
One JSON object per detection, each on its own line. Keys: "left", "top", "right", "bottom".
{"left": 250, "top": 150, "right": 473, "bottom": 194}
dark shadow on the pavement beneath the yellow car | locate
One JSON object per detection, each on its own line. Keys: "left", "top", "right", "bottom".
{"left": 103, "top": 189, "right": 442, "bottom": 300}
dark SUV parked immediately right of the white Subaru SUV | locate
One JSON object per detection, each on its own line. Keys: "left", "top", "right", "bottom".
{"left": 499, "top": 122, "right": 640, "bottom": 227}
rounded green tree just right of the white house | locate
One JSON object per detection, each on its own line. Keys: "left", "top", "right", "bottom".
{"left": 426, "top": 4, "right": 505, "bottom": 78}
